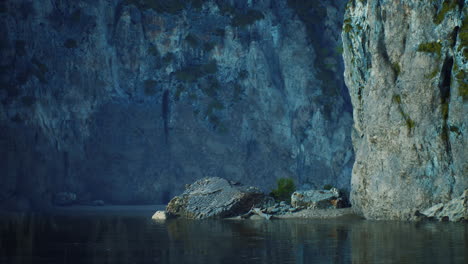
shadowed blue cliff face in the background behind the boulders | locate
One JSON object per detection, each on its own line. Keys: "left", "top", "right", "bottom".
{"left": 0, "top": 0, "right": 352, "bottom": 208}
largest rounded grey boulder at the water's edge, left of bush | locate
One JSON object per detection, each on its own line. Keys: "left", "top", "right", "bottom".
{"left": 166, "top": 177, "right": 266, "bottom": 219}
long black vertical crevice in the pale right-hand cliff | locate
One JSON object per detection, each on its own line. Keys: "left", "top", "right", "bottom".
{"left": 439, "top": 56, "right": 453, "bottom": 156}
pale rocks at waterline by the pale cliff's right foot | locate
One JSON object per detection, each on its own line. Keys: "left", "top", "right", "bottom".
{"left": 421, "top": 189, "right": 468, "bottom": 222}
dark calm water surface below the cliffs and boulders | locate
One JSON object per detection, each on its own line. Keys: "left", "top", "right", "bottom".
{"left": 0, "top": 207, "right": 468, "bottom": 263}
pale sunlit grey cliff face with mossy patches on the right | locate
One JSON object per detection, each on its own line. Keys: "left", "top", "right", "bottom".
{"left": 342, "top": 0, "right": 468, "bottom": 219}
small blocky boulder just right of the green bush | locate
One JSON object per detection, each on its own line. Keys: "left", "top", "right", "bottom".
{"left": 291, "top": 188, "right": 343, "bottom": 209}
